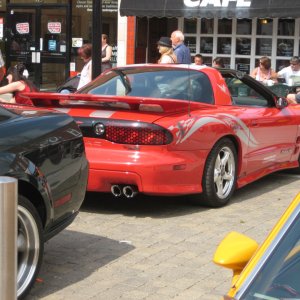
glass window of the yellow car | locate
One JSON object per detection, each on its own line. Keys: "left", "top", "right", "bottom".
{"left": 237, "top": 207, "right": 300, "bottom": 300}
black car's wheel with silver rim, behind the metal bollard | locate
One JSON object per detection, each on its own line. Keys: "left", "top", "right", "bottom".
{"left": 17, "top": 195, "right": 44, "bottom": 299}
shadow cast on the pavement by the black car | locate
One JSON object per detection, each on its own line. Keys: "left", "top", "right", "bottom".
{"left": 26, "top": 229, "right": 135, "bottom": 300}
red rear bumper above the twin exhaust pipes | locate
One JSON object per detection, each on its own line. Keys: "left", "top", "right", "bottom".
{"left": 86, "top": 145, "right": 205, "bottom": 196}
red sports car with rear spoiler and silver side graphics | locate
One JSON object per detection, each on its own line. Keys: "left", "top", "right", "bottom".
{"left": 28, "top": 64, "right": 300, "bottom": 207}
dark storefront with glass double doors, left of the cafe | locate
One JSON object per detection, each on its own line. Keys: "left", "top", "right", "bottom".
{"left": 0, "top": 0, "right": 118, "bottom": 90}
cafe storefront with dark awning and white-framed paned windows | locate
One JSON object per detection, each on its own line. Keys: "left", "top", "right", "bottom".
{"left": 120, "top": 0, "right": 300, "bottom": 73}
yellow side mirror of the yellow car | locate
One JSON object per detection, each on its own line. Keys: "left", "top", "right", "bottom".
{"left": 213, "top": 232, "right": 258, "bottom": 282}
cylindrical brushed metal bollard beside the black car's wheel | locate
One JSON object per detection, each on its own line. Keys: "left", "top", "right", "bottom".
{"left": 0, "top": 176, "right": 18, "bottom": 300}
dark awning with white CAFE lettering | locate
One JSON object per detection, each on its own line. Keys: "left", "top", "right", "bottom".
{"left": 120, "top": 0, "right": 300, "bottom": 18}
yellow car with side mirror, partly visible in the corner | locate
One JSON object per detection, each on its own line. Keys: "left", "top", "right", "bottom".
{"left": 213, "top": 193, "right": 300, "bottom": 300}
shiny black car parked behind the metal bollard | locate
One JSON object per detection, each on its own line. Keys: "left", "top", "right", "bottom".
{"left": 0, "top": 105, "right": 88, "bottom": 299}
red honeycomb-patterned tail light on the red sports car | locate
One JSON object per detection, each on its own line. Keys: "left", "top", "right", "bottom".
{"left": 105, "top": 123, "right": 173, "bottom": 145}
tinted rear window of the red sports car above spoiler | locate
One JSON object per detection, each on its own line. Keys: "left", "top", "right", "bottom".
{"left": 78, "top": 67, "right": 214, "bottom": 104}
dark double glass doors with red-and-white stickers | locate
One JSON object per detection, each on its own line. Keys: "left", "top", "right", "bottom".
{"left": 6, "top": 4, "right": 72, "bottom": 91}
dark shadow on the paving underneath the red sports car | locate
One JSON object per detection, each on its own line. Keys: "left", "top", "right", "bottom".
{"left": 81, "top": 172, "right": 300, "bottom": 218}
